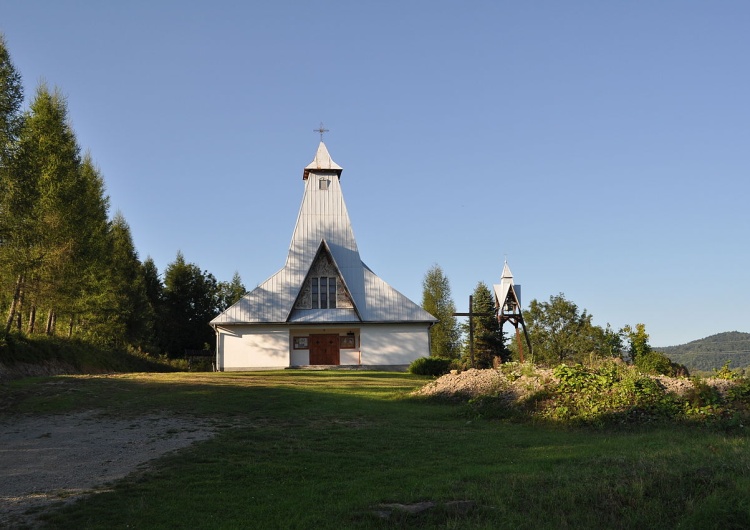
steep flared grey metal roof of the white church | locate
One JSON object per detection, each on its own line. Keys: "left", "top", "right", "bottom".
{"left": 211, "top": 142, "right": 437, "bottom": 324}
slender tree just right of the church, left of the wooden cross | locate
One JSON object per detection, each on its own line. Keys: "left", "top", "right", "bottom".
{"left": 422, "top": 264, "right": 459, "bottom": 359}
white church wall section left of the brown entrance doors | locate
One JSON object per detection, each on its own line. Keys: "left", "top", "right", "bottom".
{"left": 217, "top": 326, "right": 289, "bottom": 371}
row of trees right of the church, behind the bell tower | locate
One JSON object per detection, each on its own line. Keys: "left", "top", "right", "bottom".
{"left": 422, "top": 265, "right": 686, "bottom": 375}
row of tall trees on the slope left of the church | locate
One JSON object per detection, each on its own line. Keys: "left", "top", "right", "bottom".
{"left": 0, "top": 34, "right": 245, "bottom": 357}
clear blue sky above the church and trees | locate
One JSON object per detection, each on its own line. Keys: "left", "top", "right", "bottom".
{"left": 0, "top": 0, "right": 750, "bottom": 347}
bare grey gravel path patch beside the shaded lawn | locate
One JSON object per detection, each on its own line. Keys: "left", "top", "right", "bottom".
{"left": 0, "top": 411, "right": 214, "bottom": 528}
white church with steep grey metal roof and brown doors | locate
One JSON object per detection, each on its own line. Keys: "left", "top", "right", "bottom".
{"left": 210, "top": 142, "right": 437, "bottom": 371}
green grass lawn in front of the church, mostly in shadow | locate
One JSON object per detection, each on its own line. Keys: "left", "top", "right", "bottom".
{"left": 0, "top": 371, "right": 750, "bottom": 529}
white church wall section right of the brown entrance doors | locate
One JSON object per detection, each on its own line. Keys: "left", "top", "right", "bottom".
{"left": 360, "top": 324, "right": 430, "bottom": 366}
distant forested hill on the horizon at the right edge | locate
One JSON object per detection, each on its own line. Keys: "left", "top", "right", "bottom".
{"left": 654, "top": 331, "right": 750, "bottom": 372}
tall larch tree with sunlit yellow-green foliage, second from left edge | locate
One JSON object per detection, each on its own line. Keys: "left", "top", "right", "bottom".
{"left": 0, "top": 85, "right": 81, "bottom": 331}
